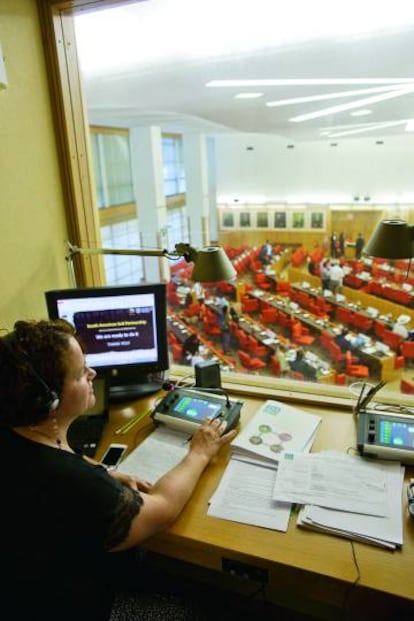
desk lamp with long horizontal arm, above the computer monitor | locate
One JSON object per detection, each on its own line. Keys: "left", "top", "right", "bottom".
{"left": 67, "top": 242, "right": 237, "bottom": 282}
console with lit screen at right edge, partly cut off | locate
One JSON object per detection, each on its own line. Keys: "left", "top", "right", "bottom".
{"left": 357, "top": 411, "right": 414, "bottom": 465}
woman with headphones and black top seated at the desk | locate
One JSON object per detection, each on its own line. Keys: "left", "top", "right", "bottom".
{"left": 0, "top": 321, "right": 235, "bottom": 621}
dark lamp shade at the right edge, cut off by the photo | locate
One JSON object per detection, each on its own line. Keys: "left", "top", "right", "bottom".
{"left": 364, "top": 220, "right": 414, "bottom": 259}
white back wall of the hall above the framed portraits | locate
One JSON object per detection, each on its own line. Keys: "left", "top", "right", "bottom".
{"left": 216, "top": 134, "right": 414, "bottom": 204}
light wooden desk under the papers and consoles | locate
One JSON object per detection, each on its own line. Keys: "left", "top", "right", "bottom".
{"left": 97, "top": 393, "right": 414, "bottom": 621}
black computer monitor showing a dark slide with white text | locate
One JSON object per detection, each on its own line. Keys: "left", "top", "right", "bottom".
{"left": 45, "top": 283, "right": 168, "bottom": 403}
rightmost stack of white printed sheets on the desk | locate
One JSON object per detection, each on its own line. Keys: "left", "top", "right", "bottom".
{"left": 273, "top": 452, "right": 404, "bottom": 549}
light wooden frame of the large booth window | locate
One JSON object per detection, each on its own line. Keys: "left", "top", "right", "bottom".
{"left": 37, "top": 0, "right": 407, "bottom": 412}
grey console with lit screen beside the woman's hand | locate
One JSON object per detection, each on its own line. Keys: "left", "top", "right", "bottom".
{"left": 151, "top": 388, "right": 243, "bottom": 432}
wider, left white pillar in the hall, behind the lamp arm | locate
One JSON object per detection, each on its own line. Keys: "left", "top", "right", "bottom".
{"left": 130, "top": 127, "right": 169, "bottom": 282}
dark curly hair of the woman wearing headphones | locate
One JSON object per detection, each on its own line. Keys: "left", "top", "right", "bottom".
{"left": 0, "top": 319, "right": 76, "bottom": 427}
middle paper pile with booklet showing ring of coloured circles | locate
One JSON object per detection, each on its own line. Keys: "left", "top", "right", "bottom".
{"left": 208, "top": 401, "right": 321, "bottom": 531}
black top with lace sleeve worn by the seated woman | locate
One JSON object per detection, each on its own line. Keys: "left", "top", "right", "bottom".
{"left": 0, "top": 429, "right": 142, "bottom": 621}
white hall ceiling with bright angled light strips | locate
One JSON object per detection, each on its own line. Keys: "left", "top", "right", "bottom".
{"left": 76, "top": 0, "right": 414, "bottom": 143}
